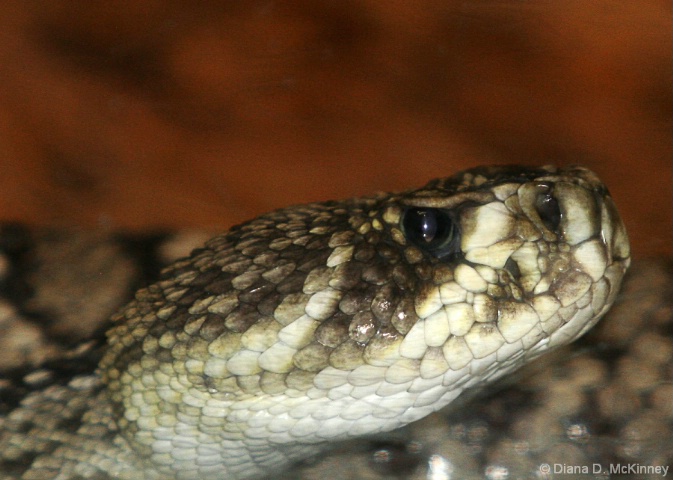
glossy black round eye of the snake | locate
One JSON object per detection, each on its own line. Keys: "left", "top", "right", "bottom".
{"left": 402, "top": 208, "right": 460, "bottom": 258}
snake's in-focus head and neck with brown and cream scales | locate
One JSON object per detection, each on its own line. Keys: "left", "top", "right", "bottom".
{"left": 0, "top": 167, "right": 630, "bottom": 479}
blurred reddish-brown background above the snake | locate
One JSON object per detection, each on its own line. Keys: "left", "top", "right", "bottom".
{"left": 0, "top": 0, "right": 673, "bottom": 256}
